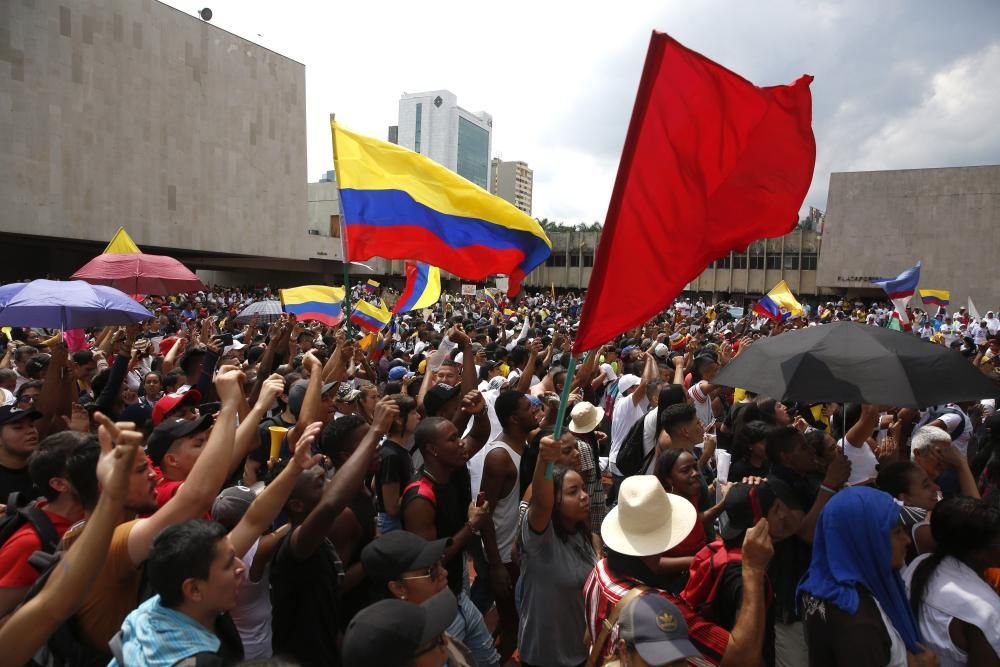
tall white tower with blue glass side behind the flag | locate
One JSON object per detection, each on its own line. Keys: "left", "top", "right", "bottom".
{"left": 396, "top": 90, "right": 493, "bottom": 190}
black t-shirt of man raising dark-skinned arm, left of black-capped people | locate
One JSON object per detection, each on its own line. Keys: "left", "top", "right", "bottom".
{"left": 271, "top": 533, "right": 344, "bottom": 667}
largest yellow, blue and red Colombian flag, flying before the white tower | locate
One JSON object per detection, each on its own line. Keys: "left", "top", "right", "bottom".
{"left": 331, "top": 121, "right": 552, "bottom": 295}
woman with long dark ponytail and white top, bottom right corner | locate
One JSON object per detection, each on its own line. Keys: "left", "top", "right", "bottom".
{"left": 903, "top": 497, "right": 1000, "bottom": 667}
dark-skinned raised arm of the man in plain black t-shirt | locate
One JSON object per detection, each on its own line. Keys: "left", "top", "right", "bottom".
{"left": 290, "top": 398, "right": 399, "bottom": 560}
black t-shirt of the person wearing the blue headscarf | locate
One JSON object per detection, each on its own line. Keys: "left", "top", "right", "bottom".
{"left": 802, "top": 586, "right": 892, "bottom": 667}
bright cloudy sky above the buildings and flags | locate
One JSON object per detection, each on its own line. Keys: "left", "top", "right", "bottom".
{"left": 160, "top": 0, "right": 1000, "bottom": 223}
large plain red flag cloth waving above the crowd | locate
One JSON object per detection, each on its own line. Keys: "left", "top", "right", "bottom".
{"left": 573, "top": 32, "right": 816, "bottom": 353}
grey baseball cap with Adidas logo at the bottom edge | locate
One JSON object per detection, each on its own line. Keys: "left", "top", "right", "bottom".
{"left": 618, "top": 593, "right": 701, "bottom": 665}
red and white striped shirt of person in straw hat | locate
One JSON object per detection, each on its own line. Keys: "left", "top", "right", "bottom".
{"left": 583, "top": 559, "right": 729, "bottom": 667}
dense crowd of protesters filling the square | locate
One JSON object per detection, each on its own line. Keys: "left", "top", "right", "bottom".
{"left": 0, "top": 289, "right": 1000, "bottom": 667}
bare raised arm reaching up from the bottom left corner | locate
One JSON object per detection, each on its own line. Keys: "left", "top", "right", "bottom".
{"left": 0, "top": 413, "right": 143, "bottom": 665}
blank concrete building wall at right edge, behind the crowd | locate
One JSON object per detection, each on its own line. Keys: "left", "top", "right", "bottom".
{"left": 817, "top": 165, "right": 1000, "bottom": 314}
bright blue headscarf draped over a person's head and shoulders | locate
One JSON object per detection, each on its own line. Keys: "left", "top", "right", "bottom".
{"left": 796, "top": 487, "right": 923, "bottom": 653}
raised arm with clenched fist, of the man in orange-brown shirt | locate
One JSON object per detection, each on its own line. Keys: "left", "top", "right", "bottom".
{"left": 128, "top": 366, "right": 245, "bottom": 566}
